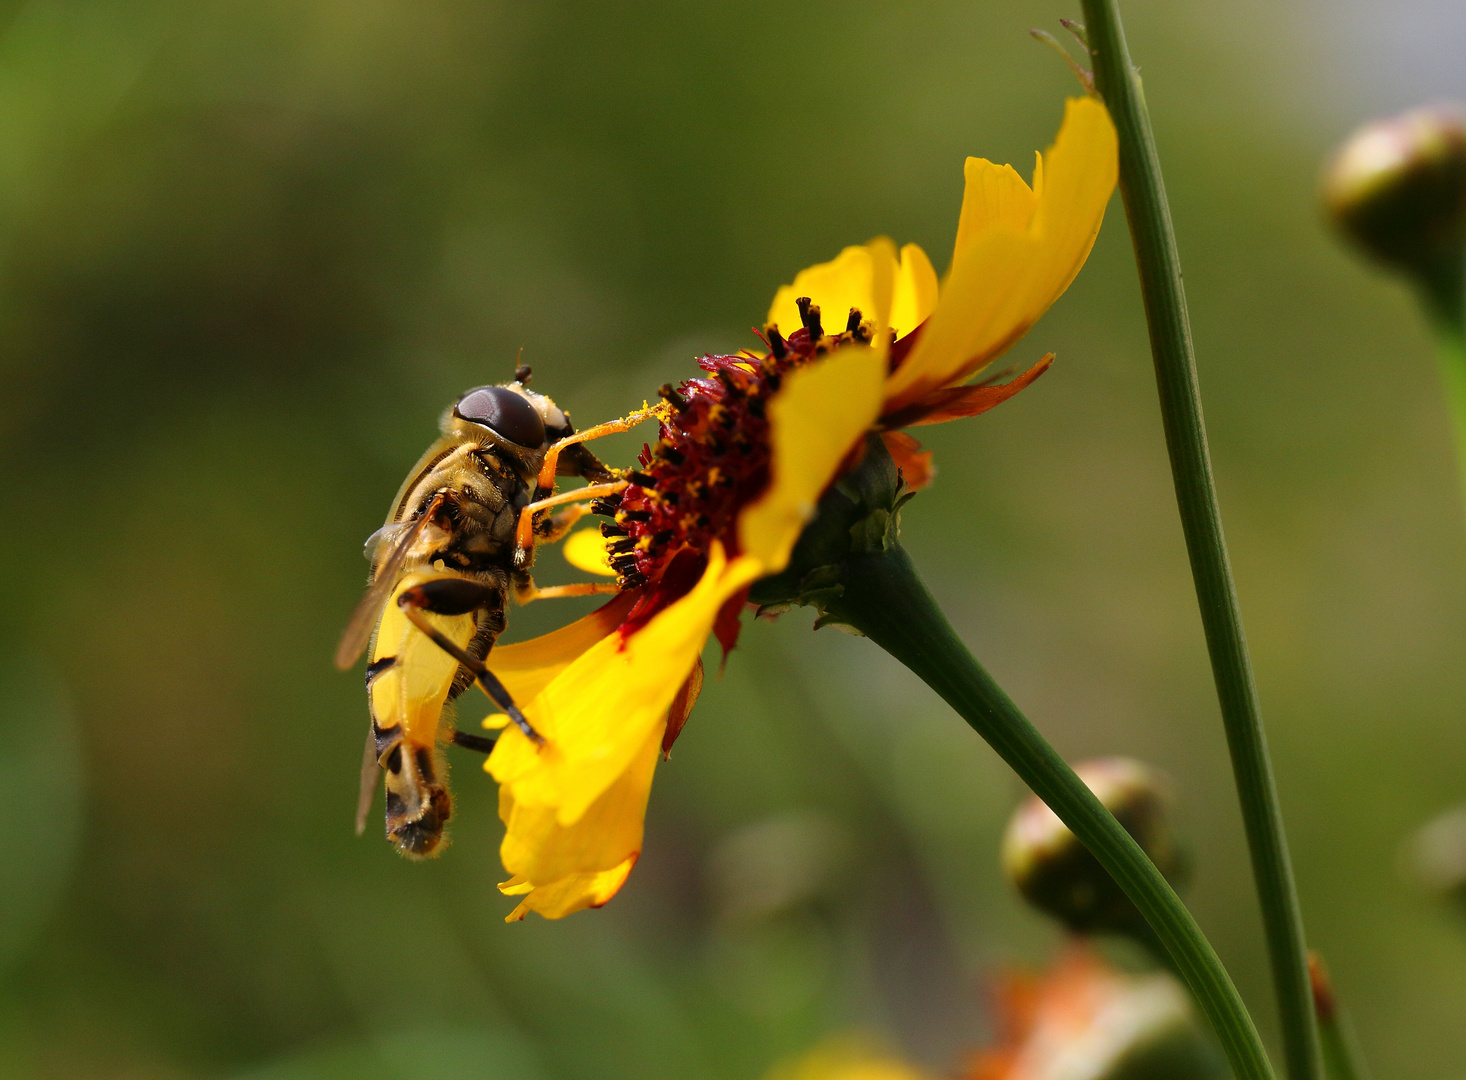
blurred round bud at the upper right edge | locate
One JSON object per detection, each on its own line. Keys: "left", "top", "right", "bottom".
{"left": 1324, "top": 104, "right": 1466, "bottom": 316}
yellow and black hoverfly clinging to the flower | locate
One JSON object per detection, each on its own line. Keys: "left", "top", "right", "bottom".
{"left": 336, "top": 366, "right": 654, "bottom": 857}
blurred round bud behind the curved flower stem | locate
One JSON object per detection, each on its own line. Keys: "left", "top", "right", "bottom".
{"left": 1003, "top": 758, "right": 1183, "bottom": 938}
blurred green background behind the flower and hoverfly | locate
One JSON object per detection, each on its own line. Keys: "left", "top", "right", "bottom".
{"left": 0, "top": 0, "right": 1466, "bottom": 1080}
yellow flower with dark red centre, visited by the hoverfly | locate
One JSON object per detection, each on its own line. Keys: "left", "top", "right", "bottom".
{"left": 487, "top": 98, "right": 1117, "bottom": 919}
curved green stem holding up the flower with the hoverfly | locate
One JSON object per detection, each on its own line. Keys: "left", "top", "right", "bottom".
{"left": 828, "top": 544, "right": 1272, "bottom": 1080}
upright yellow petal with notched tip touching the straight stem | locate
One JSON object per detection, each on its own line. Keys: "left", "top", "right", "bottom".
{"left": 887, "top": 98, "right": 1119, "bottom": 412}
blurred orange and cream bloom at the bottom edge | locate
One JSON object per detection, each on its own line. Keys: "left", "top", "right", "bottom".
{"left": 963, "top": 945, "right": 1229, "bottom": 1080}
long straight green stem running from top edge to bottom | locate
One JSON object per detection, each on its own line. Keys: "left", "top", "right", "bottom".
{"left": 1080, "top": 0, "right": 1321, "bottom": 1080}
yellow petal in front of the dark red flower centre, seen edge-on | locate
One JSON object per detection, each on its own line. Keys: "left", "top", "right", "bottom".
{"left": 737, "top": 346, "right": 885, "bottom": 573}
